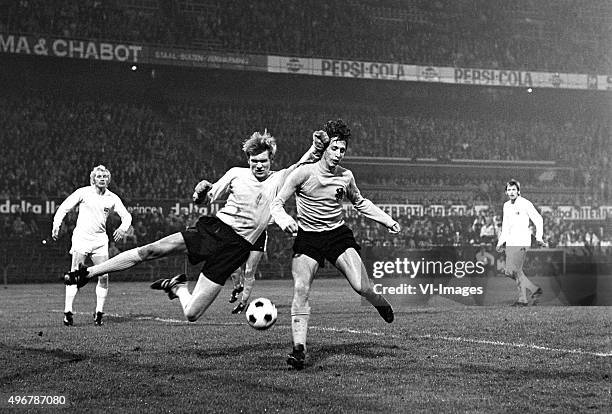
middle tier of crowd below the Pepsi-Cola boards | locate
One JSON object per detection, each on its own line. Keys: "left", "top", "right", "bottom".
{"left": 0, "top": 95, "right": 612, "bottom": 205}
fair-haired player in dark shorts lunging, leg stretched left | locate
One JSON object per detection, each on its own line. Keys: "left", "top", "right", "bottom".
{"left": 65, "top": 131, "right": 320, "bottom": 322}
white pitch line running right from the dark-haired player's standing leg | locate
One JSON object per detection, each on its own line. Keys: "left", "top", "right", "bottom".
{"left": 311, "top": 326, "right": 612, "bottom": 358}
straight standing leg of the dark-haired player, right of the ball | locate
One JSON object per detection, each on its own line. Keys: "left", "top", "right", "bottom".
{"left": 287, "top": 254, "right": 319, "bottom": 370}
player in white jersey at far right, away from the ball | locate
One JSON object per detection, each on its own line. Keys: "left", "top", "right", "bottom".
{"left": 497, "top": 180, "right": 544, "bottom": 306}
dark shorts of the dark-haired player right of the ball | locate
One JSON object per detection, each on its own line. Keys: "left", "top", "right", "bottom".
{"left": 293, "top": 225, "right": 361, "bottom": 267}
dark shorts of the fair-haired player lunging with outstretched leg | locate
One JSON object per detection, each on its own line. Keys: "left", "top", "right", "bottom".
{"left": 181, "top": 216, "right": 253, "bottom": 285}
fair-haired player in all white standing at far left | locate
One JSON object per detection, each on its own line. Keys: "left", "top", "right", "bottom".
{"left": 51, "top": 165, "right": 132, "bottom": 326}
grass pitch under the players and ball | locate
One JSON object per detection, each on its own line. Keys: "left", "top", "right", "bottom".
{"left": 0, "top": 279, "right": 612, "bottom": 414}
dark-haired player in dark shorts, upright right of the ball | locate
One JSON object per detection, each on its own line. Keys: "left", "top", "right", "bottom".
{"left": 271, "top": 119, "right": 400, "bottom": 370}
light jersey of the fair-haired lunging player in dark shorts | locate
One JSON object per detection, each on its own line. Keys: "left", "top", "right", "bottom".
{"left": 208, "top": 167, "right": 289, "bottom": 244}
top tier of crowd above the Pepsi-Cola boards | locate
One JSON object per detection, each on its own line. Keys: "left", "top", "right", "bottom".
{"left": 0, "top": 0, "right": 612, "bottom": 73}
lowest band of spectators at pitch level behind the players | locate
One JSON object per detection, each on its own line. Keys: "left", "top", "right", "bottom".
{"left": 0, "top": 202, "right": 612, "bottom": 277}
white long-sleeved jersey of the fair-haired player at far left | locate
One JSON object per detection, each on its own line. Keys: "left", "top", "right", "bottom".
{"left": 53, "top": 186, "right": 132, "bottom": 253}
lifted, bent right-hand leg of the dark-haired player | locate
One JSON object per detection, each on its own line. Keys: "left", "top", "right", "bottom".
{"left": 335, "top": 247, "right": 395, "bottom": 323}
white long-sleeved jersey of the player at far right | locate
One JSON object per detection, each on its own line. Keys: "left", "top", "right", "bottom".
{"left": 497, "top": 196, "right": 543, "bottom": 247}
